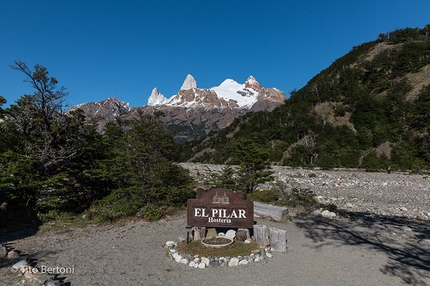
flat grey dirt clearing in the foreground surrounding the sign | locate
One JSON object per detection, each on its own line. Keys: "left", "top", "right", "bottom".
{"left": 0, "top": 216, "right": 430, "bottom": 286}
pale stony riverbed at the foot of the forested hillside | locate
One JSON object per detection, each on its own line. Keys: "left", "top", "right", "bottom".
{"left": 181, "top": 163, "right": 430, "bottom": 220}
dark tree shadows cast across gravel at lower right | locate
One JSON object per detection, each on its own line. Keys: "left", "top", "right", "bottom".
{"left": 296, "top": 213, "right": 430, "bottom": 285}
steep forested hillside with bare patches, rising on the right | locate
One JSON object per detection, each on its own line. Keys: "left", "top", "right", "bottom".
{"left": 181, "top": 25, "right": 430, "bottom": 171}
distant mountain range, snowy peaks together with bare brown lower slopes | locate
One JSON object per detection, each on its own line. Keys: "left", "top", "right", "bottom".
{"left": 72, "top": 75, "right": 287, "bottom": 142}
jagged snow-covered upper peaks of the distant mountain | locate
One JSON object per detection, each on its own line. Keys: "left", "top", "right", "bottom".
{"left": 148, "top": 74, "right": 286, "bottom": 110}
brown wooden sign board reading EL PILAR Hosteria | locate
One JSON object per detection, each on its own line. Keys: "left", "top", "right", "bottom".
{"left": 187, "top": 188, "right": 254, "bottom": 228}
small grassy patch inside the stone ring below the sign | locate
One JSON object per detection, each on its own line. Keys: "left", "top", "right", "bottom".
{"left": 176, "top": 241, "right": 260, "bottom": 257}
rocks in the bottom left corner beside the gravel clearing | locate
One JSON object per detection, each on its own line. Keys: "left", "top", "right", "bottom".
{"left": 0, "top": 244, "right": 61, "bottom": 286}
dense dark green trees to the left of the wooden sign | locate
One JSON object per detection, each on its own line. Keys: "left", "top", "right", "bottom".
{"left": 0, "top": 61, "right": 192, "bottom": 223}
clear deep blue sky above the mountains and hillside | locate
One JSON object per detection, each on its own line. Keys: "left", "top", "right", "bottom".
{"left": 0, "top": 0, "right": 430, "bottom": 107}
